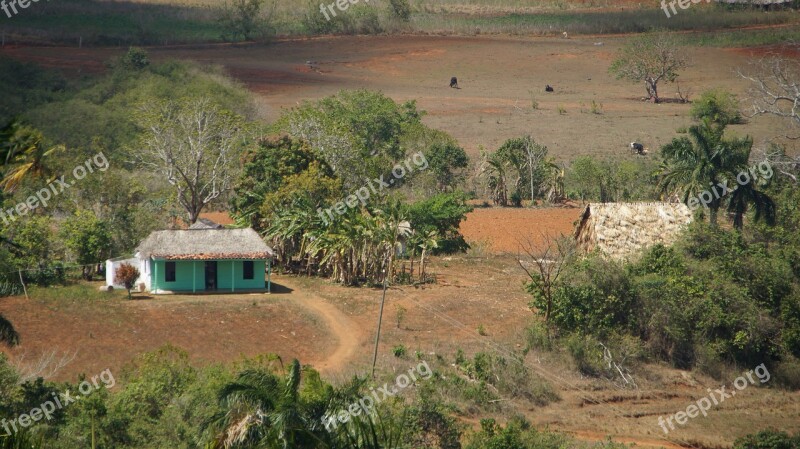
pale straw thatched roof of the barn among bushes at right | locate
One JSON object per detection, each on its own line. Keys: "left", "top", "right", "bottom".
{"left": 575, "top": 203, "right": 692, "bottom": 259}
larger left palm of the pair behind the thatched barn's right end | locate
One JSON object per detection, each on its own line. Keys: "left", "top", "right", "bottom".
{"left": 659, "top": 120, "right": 752, "bottom": 225}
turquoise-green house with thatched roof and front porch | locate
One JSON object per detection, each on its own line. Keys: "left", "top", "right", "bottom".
{"left": 136, "top": 226, "right": 273, "bottom": 293}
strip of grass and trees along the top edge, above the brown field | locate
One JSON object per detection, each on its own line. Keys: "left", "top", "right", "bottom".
{"left": 5, "top": 0, "right": 797, "bottom": 46}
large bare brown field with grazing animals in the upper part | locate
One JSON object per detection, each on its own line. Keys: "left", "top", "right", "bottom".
{"left": 0, "top": 36, "right": 796, "bottom": 160}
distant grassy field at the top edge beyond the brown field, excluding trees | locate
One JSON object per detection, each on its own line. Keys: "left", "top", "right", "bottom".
{"left": 0, "top": 0, "right": 800, "bottom": 46}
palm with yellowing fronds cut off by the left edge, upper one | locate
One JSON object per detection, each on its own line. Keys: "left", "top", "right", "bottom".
{"left": 0, "top": 121, "right": 64, "bottom": 192}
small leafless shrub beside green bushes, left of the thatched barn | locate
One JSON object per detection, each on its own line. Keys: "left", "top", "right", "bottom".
{"left": 517, "top": 233, "right": 578, "bottom": 321}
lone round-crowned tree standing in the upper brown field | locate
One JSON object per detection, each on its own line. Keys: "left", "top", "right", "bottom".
{"left": 609, "top": 32, "right": 688, "bottom": 103}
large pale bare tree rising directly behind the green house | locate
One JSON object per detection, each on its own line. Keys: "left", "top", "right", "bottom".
{"left": 136, "top": 98, "right": 243, "bottom": 223}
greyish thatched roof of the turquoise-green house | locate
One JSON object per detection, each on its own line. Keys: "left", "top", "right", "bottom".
{"left": 136, "top": 228, "right": 273, "bottom": 260}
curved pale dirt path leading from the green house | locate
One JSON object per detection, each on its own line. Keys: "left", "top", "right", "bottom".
{"left": 281, "top": 278, "right": 362, "bottom": 375}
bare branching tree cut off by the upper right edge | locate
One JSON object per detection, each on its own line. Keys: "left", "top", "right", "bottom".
{"left": 739, "top": 45, "right": 800, "bottom": 139}
